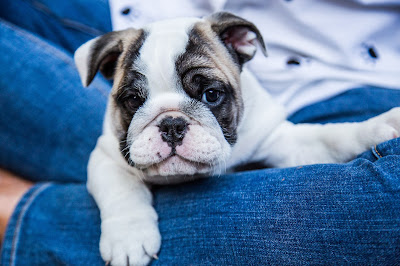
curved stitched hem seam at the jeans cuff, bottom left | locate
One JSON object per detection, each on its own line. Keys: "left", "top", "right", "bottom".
{"left": 10, "top": 183, "right": 51, "bottom": 265}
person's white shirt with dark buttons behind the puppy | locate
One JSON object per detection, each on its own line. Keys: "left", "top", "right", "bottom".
{"left": 110, "top": 0, "right": 400, "bottom": 114}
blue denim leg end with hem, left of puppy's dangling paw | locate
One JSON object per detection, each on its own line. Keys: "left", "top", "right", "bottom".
{"left": 0, "top": 183, "right": 104, "bottom": 265}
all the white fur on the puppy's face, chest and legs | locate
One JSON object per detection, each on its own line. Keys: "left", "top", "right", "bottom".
{"left": 75, "top": 16, "right": 400, "bottom": 265}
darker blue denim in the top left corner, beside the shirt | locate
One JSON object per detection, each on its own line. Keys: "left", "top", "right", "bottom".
{"left": 0, "top": 0, "right": 112, "bottom": 53}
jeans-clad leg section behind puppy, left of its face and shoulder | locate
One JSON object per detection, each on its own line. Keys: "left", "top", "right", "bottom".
{"left": 0, "top": 20, "right": 110, "bottom": 182}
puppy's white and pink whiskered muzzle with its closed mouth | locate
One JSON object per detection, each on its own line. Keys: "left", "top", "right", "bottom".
{"left": 129, "top": 119, "right": 226, "bottom": 183}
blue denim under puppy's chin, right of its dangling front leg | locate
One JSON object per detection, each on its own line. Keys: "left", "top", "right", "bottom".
{"left": 155, "top": 139, "right": 400, "bottom": 265}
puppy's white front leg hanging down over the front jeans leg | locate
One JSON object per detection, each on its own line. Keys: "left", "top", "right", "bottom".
{"left": 87, "top": 136, "right": 161, "bottom": 266}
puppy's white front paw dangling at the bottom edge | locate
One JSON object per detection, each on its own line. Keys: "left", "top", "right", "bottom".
{"left": 100, "top": 218, "right": 161, "bottom": 266}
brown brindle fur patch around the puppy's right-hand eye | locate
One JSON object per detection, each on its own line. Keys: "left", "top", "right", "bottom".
{"left": 175, "top": 21, "right": 243, "bottom": 144}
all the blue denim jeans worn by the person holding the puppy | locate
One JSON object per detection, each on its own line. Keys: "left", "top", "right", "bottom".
{"left": 0, "top": 0, "right": 400, "bottom": 265}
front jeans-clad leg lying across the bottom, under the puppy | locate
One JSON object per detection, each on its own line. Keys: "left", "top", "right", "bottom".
{"left": 0, "top": 139, "right": 400, "bottom": 266}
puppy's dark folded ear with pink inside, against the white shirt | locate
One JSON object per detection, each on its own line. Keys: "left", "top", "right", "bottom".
{"left": 205, "top": 12, "right": 267, "bottom": 65}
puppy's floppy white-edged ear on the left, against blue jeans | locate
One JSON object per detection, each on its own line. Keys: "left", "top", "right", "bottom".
{"left": 74, "top": 29, "right": 141, "bottom": 87}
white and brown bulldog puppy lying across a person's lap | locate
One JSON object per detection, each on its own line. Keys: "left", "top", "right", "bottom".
{"left": 75, "top": 13, "right": 400, "bottom": 265}
